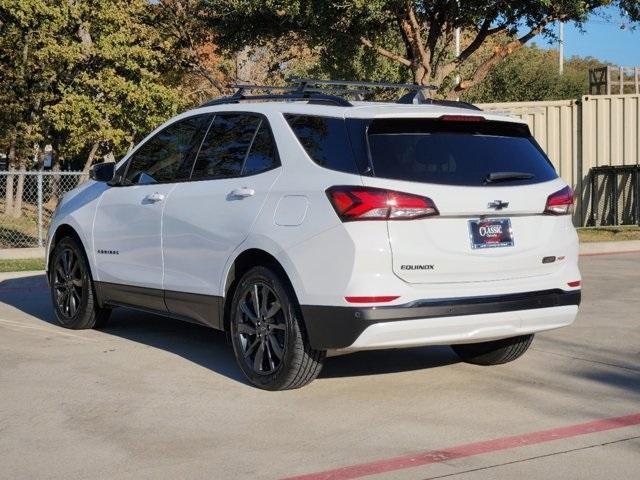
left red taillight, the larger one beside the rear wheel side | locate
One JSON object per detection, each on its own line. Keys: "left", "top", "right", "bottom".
{"left": 327, "top": 187, "right": 438, "bottom": 222}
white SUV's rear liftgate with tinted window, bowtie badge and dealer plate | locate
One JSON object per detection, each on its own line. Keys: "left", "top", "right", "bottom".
{"left": 364, "top": 116, "right": 571, "bottom": 283}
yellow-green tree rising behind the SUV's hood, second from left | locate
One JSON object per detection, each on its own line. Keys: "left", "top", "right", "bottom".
{"left": 46, "top": 0, "right": 184, "bottom": 168}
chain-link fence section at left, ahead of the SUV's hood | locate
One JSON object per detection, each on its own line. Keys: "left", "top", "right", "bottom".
{"left": 0, "top": 171, "right": 87, "bottom": 248}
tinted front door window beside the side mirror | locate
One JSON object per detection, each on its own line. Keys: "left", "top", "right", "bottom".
{"left": 124, "top": 115, "right": 210, "bottom": 185}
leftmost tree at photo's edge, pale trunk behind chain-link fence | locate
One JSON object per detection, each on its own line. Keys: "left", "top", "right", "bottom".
{"left": 0, "top": 0, "right": 69, "bottom": 216}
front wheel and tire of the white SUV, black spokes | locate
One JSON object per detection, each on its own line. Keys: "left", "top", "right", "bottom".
{"left": 49, "top": 237, "right": 111, "bottom": 330}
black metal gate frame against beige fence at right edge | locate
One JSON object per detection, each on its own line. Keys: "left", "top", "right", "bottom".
{"left": 588, "top": 165, "right": 640, "bottom": 227}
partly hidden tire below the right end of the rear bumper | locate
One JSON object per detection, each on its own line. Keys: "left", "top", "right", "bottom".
{"left": 451, "top": 334, "right": 533, "bottom": 365}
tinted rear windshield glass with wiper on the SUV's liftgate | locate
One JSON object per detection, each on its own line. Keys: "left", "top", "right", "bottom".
{"left": 368, "top": 119, "right": 557, "bottom": 186}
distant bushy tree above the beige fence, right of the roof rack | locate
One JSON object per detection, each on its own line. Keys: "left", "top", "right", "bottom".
{"left": 462, "top": 45, "right": 603, "bottom": 103}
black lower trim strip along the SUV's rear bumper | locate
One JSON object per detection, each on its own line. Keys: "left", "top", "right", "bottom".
{"left": 302, "top": 289, "right": 580, "bottom": 350}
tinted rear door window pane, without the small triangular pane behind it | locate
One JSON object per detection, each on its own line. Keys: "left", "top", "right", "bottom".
{"left": 191, "top": 113, "right": 261, "bottom": 180}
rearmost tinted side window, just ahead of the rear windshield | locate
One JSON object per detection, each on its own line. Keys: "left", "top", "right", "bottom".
{"left": 285, "top": 115, "right": 358, "bottom": 173}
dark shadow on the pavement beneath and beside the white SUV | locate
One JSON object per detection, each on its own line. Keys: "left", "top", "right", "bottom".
{"left": 0, "top": 274, "right": 459, "bottom": 383}
